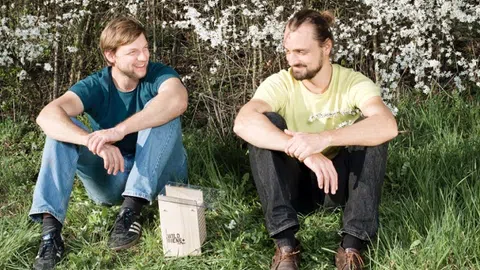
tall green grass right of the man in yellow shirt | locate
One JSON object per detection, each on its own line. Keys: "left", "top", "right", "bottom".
{"left": 372, "top": 94, "right": 480, "bottom": 269}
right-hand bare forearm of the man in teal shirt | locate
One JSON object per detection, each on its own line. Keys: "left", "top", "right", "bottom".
{"left": 115, "top": 93, "right": 187, "bottom": 135}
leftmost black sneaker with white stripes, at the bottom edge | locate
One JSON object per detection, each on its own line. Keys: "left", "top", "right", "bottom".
{"left": 33, "top": 230, "right": 65, "bottom": 270}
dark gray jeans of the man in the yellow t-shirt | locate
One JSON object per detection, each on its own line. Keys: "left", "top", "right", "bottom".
{"left": 249, "top": 112, "right": 388, "bottom": 241}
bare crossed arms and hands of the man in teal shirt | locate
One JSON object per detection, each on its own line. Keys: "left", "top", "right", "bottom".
{"left": 37, "top": 78, "right": 188, "bottom": 174}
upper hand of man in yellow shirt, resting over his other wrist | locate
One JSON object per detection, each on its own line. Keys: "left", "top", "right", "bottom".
{"left": 284, "top": 129, "right": 330, "bottom": 161}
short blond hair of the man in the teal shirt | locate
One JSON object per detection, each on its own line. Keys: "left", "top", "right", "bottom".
{"left": 100, "top": 17, "right": 146, "bottom": 65}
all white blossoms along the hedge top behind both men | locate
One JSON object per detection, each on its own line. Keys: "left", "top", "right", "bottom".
{"left": 0, "top": 0, "right": 480, "bottom": 99}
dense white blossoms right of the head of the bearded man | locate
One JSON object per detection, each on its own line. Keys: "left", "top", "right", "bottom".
{"left": 334, "top": 0, "right": 480, "bottom": 94}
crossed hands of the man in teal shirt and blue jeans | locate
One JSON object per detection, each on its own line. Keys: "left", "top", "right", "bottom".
{"left": 85, "top": 127, "right": 125, "bottom": 175}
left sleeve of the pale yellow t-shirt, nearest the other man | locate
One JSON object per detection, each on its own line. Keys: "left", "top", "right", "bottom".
{"left": 252, "top": 73, "right": 288, "bottom": 113}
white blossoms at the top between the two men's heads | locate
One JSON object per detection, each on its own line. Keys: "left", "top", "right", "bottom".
{"left": 172, "top": 0, "right": 301, "bottom": 50}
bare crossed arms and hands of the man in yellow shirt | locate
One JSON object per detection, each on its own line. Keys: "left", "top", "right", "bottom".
{"left": 234, "top": 97, "right": 398, "bottom": 194}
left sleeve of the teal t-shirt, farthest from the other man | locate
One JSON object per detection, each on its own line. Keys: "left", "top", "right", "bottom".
{"left": 70, "top": 74, "right": 104, "bottom": 114}
